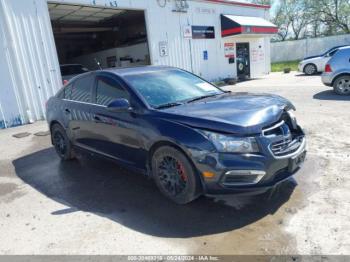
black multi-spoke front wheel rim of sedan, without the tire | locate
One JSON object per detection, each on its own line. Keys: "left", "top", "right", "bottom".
{"left": 157, "top": 156, "right": 187, "bottom": 196}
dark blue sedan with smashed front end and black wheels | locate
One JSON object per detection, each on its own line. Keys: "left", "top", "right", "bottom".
{"left": 47, "top": 66, "right": 306, "bottom": 204}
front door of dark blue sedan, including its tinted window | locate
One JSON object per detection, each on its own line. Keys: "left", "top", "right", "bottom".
{"left": 90, "top": 75, "right": 143, "bottom": 167}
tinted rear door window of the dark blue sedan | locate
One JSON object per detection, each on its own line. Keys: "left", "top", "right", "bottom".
{"left": 71, "top": 75, "right": 94, "bottom": 102}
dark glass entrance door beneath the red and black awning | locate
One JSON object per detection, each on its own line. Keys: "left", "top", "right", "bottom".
{"left": 236, "top": 43, "right": 250, "bottom": 80}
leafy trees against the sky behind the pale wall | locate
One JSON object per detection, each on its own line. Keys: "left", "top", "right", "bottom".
{"left": 252, "top": 0, "right": 350, "bottom": 41}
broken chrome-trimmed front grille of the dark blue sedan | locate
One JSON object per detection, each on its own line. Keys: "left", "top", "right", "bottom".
{"left": 263, "top": 118, "right": 304, "bottom": 157}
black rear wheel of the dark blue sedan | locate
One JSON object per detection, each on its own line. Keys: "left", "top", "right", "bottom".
{"left": 51, "top": 124, "right": 75, "bottom": 161}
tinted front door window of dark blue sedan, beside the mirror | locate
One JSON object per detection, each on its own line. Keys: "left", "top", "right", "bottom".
{"left": 96, "top": 77, "right": 129, "bottom": 106}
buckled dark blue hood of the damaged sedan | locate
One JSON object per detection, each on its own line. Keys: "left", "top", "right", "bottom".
{"left": 160, "top": 93, "right": 295, "bottom": 134}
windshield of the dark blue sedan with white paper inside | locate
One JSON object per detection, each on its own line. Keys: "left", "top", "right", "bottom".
{"left": 125, "top": 69, "right": 224, "bottom": 108}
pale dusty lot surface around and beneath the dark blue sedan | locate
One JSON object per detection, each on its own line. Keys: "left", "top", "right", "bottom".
{"left": 0, "top": 73, "right": 350, "bottom": 255}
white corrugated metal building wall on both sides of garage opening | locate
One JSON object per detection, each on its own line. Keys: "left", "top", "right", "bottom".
{"left": 0, "top": 0, "right": 269, "bottom": 128}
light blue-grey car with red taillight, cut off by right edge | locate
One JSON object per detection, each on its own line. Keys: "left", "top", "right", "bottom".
{"left": 322, "top": 47, "right": 350, "bottom": 95}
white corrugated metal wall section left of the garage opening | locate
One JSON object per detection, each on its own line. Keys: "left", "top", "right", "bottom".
{"left": 0, "top": 0, "right": 60, "bottom": 127}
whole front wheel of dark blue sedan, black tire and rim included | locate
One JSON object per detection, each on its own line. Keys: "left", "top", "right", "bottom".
{"left": 152, "top": 146, "right": 202, "bottom": 205}
